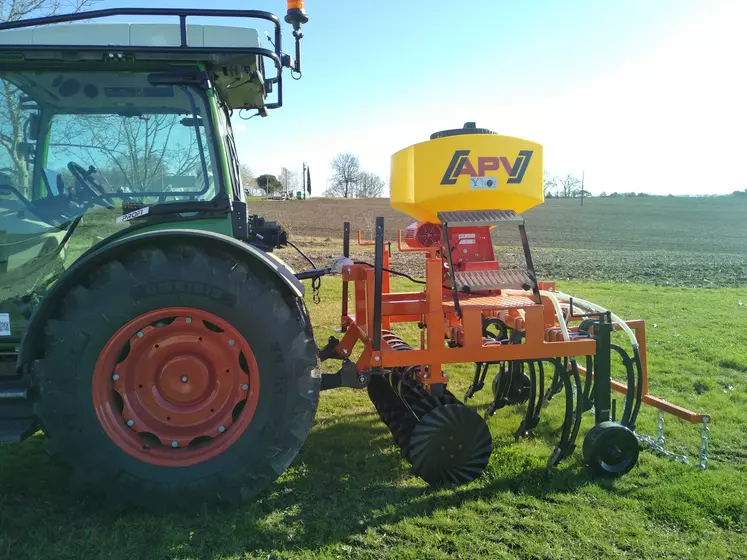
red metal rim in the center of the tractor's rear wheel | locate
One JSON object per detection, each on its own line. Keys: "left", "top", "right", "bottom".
{"left": 92, "top": 307, "right": 259, "bottom": 467}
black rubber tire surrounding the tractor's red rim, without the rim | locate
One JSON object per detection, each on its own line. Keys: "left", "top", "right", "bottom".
{"left": 32, "top": 242, "right": 320, "bottom": 511}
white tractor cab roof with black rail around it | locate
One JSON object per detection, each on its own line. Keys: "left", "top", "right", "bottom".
{"left": 0, "top": 8, "right": 292, "bottom": 114}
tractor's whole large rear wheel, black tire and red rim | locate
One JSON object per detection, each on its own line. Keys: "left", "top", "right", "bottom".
{"left": 33, "top": 244, "right": 320, "bottom": 510}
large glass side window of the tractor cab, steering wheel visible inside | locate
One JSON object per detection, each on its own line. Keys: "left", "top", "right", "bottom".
{"left": 0, "top": 70, "right": 226, "bottom": 337}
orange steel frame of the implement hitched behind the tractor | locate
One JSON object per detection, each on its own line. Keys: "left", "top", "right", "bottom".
{"left": 336, "top": 231, "right": 709, "bottom": 424}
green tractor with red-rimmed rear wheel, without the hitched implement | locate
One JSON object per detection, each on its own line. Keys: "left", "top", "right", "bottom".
{"left": 0, "top": 2, "right": 321, "bottom": 508}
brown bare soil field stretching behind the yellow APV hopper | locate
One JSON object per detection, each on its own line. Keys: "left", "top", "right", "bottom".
{"left": 254, "top": 196, "right": 747, "bottom": 288}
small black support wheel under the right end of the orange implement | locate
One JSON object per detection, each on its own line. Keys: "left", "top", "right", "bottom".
{"left": 583, "top": 422, "right": 640, "bottom": 477}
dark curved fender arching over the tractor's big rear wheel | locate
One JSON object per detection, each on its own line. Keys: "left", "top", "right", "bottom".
{"left": 17, "top": 229, "right": 305, "bottom": 371}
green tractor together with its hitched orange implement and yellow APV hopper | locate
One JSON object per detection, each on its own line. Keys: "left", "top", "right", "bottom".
{"left": 0, "top": 4, "right": 708, "bottom": 511}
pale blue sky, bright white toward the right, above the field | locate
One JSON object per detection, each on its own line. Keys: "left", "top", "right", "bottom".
{"left": 100, "top": 0, "right": 747, "bottom": 194}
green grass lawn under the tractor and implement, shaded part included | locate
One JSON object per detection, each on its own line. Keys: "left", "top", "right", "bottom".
{"left": 0, "top": 279, "right": 747, "bottom": 560}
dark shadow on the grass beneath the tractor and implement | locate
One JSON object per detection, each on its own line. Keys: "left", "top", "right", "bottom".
{"left": 0, "top": 406, "right": 668, "bottom": 558}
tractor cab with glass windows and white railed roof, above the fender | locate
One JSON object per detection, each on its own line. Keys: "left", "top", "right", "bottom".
{"left": 0, "top": 9, "right": 305, "bottom": 342}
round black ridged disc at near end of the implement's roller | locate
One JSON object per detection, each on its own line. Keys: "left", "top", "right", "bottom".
{"left": 406, "top": 403, "right": 492, "bottom": 485}
